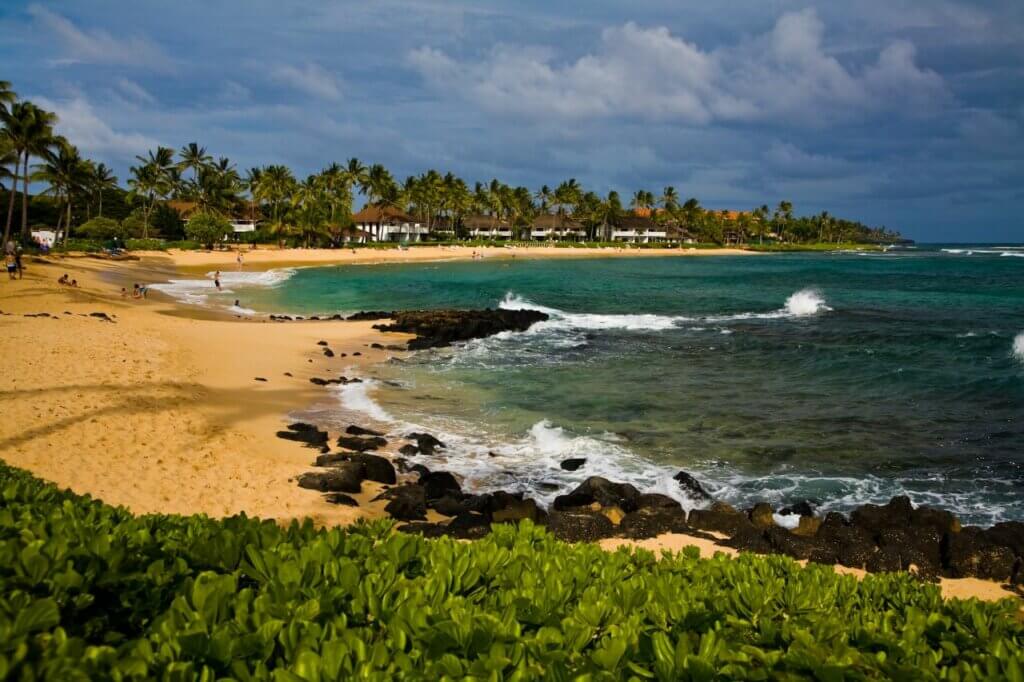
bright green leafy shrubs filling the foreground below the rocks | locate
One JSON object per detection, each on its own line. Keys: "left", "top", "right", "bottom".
{"left": 0, "top": 464, "right": 1024, "bottom": 681}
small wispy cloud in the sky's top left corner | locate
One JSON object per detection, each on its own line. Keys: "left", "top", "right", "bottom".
{"left": 28, "top": 4, "right": 172, "bottom": 70}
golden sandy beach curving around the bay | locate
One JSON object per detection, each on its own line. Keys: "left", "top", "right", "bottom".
{"left": 0, "top": 247, "right": 1011, "bottom": 599}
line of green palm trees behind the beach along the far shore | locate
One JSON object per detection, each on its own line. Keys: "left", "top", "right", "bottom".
{"left": 0, "top": 81, "right": 899, "bottom": 245}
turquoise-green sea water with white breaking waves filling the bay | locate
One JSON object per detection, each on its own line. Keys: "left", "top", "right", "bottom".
{"left": 186, "top": 247, "right": 1024, "bottom": 523}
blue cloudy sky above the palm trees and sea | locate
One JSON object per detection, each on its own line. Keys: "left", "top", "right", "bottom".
{"left": 0, "top": 0, "right": 1024, "bottom": 242}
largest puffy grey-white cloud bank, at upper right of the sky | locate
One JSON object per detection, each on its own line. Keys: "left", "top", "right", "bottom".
{"left": 408, "top": 9, "right": 948, "bottom": 124}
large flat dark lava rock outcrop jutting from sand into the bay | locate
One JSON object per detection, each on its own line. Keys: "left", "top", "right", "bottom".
{"left": 374, "top": 309, "right": 548, "bottom": 350}
